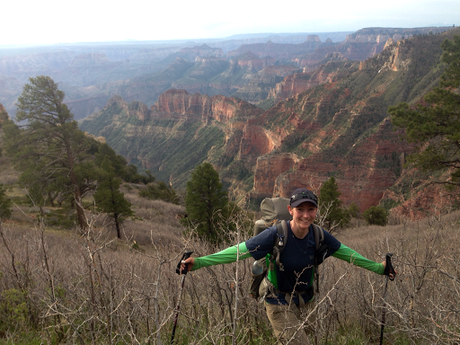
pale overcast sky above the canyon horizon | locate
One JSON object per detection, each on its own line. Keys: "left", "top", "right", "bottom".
{"left": 0, "top": 0, "right": 460, "bottom": 46}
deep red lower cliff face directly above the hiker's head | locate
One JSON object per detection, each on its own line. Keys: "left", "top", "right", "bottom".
{"left": 252, "top": 121, "right": 411, "bottom": 211}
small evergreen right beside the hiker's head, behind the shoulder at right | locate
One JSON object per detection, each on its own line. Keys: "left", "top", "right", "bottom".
{"left": 318, "top": 176, "right": 350, "bottom": 231}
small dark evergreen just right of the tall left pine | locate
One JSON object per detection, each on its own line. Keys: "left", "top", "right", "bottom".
{"left": 94, "top": 157, "right": 134, "bottom": 238}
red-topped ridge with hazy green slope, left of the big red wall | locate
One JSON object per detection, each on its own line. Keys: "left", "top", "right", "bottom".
{"left": 80, "top": 89, "right": 262, "bottom": 185}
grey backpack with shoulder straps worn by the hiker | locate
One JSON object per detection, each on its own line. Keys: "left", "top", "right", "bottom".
{"left": 249, "top": 197, "right": 328, "bottom": 300}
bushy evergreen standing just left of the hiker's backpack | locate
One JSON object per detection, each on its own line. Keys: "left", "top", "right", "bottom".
{"left": 185, "top": 163, "right": 228, "bottom": 242}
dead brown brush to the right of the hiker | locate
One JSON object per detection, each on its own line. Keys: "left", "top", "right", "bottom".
{"left": 321, "top": 212, "right": 460, "bottom": 344}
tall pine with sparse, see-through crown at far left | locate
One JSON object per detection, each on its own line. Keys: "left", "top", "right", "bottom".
{"left": 4, "top": 76, "right": 92, "bottom": 229}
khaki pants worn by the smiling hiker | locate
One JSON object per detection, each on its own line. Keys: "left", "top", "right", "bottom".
{"left": 265, "top": 301, "right": 315, "bottom": 345}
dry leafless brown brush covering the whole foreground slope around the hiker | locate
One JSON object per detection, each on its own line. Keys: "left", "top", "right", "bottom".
{"left": 0, "top": 198, "right": 460, "bottom": 344}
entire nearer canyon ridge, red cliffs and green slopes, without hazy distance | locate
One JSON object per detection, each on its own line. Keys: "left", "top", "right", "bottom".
{"left": 81, "top": 26, "right": 460, "bottom": 218}
